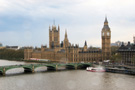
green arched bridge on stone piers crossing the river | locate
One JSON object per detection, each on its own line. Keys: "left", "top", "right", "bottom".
{"left": 0, "top": 63, "right": 92, "bottom": 75}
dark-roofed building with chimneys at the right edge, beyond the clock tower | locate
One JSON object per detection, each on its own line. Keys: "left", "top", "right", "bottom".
{"left": 118, "top": 42, "right": 135, "bottom": 66}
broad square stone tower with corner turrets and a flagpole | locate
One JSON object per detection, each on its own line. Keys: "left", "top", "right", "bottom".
{"left": 49, "top": 25, "right": 60, "bottom": 48}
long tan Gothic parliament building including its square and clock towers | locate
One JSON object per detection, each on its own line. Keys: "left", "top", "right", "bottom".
{"left": 24, "top": 18, "right": 111, "bottom": 63}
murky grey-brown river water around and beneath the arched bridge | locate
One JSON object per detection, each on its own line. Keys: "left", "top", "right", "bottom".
{"left": 0, "top": 60, "right": 135, "bottom": 90}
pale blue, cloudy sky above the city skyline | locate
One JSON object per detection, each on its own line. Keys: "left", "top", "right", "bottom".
{"left": 0, "top": 0, "right": 135, "bottom": 47}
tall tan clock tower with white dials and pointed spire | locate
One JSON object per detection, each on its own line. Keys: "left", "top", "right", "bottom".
{"left": 101, "top": 17, "right": 111, "bottom": 60}
